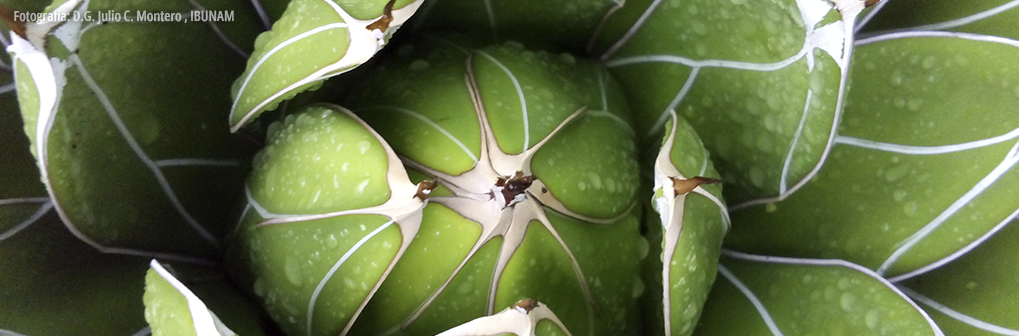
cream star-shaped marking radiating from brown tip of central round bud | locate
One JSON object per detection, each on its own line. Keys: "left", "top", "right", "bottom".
{"left": 387, "top": 55, "right": 633, "bottom": 329}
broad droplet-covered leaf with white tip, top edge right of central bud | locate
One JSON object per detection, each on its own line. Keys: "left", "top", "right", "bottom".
{"left": 597, "top": 0, "right": 863, "bottom": 206}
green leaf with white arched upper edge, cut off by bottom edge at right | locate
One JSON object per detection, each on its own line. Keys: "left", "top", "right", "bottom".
{"left": 694, "top": 253, "right": 945, "bottom": 336}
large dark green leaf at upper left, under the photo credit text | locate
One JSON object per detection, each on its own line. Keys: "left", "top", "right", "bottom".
{"left": 10, "top": 1, "right": 258, "bottom": 262}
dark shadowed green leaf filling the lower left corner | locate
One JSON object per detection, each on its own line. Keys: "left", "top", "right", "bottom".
{"left": 0, "top": 110, "right": 145, "bottom": 335}
